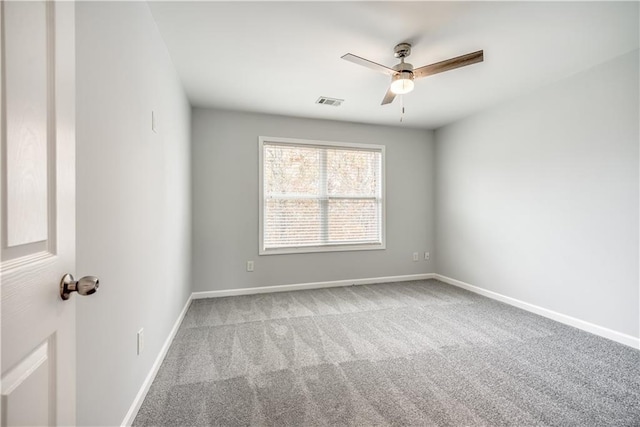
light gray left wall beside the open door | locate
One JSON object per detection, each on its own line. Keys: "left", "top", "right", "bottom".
{"left": 76, "top": 2, "right": 191, "bottom": 425}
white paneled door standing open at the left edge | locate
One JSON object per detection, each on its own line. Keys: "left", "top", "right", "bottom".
{"left": 0, "top": 1, "right": 77, "bottom": 426}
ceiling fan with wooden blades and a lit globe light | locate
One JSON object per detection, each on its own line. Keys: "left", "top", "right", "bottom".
{"left": 342, "top": 43, "right": 484, "bottom": 105}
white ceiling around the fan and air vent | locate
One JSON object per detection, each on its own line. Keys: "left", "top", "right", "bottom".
{"left": 150, "top": 2, "right": 639, "bottom": 129}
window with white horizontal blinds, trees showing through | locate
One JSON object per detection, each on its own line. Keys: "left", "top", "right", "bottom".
{"left": 259, "top": 137, "right": 385, "bottom": 255}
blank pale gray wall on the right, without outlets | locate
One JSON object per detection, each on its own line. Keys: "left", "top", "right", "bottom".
{"left": 435, "top": 51, "right": 639, "bottom": 337}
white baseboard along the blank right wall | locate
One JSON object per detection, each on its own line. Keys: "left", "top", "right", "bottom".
{"left": 434, "top": 274, "right": 640, "bottom": 349}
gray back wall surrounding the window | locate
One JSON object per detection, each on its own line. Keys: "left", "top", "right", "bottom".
{"left": 192, "top": 109, "right": 434, "bottom": 291}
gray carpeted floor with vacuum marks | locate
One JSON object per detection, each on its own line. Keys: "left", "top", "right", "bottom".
{"left": 134, "top": 280, "right": 640, "bottom": 426}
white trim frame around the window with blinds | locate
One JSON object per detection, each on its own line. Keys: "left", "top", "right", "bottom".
{"left": 258, "top": 136, "right": 387, "bottom": 255}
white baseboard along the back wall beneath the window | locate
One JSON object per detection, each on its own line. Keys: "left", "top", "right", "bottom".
{"left": 191, "top": 273, "right": 434, "bottom": 299}
